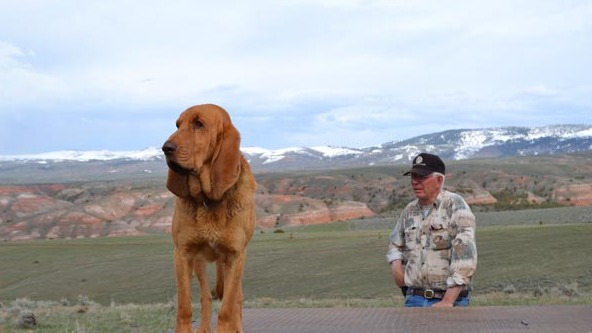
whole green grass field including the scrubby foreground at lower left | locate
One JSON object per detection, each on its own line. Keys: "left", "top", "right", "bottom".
{"left": 0, "top": 219, "right": 592, "bottom": 332}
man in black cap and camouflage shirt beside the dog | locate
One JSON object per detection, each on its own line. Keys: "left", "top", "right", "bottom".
{"left": 386, "top": 153, "right": 477, "bottom": 307}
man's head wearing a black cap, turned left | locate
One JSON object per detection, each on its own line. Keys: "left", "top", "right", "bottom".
{"left": 403, "top": 153, "right": 446, "bottom": 205}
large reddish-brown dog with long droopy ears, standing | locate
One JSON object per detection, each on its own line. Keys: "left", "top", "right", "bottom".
{"left": 162, "top": 104, "right": 256, "bottom": 333}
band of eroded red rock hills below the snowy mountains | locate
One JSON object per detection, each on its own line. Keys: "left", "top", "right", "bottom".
{"left": 0, "top": 159, "right": 592, "bottom": 241}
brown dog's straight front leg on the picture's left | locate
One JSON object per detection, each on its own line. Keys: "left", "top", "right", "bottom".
{"left": 175, "top": 248, "right": 192, "bottom": 333}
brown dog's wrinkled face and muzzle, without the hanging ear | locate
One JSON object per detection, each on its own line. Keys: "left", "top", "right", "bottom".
{"left": 162, "top": 105, "right": 228, "bottom": 174}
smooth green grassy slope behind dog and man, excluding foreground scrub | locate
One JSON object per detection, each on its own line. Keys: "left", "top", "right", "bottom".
{"left": 0, "top": 217, "right": 592, "bottom": 304}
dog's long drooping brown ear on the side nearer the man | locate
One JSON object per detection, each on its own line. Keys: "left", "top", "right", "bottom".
{"left": 210, "top": 121, "right": 241, "bottom": 200}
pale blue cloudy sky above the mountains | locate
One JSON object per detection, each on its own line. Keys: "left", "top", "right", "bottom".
{"left": 0, "top": 0, "right": 592, "bottom": 155}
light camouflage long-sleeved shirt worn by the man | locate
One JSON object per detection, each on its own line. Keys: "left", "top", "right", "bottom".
{"left": 386, "top": 191, "right": 477, "bottom": 290}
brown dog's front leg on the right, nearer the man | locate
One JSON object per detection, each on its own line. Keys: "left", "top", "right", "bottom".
{"left": 216, "top": 251, "right": 246, "bottom": 333}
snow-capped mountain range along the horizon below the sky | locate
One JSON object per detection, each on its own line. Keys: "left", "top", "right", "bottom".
{"left": 0, "top": 125, "right": 592, "bottom": 172}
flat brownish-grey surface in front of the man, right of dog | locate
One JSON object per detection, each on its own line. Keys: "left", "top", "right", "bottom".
{"left": 229, "top": 305, "right": 592, "bottom": 333}
